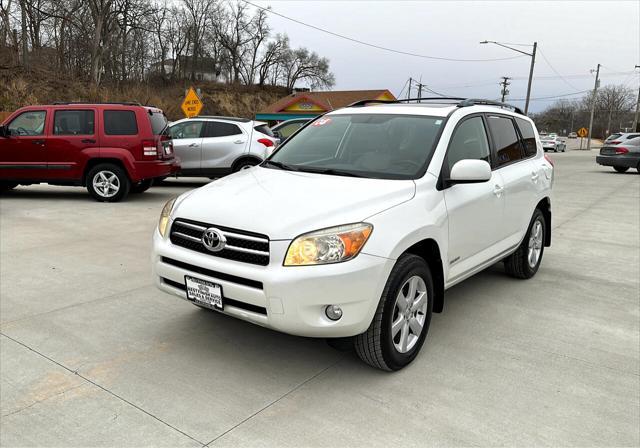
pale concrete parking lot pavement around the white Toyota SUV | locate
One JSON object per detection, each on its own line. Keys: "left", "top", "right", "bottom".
{"left": 0, "top": 146, "right": 640, "bottom": 447}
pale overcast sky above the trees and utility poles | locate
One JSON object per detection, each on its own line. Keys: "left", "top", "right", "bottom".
{"left": 251, "top": 0, "right": 640, "bottom": 112}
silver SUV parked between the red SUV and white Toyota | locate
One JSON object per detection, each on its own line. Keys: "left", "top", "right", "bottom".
{"left": 169, "top": 116, "right": 278, "bottom": 177}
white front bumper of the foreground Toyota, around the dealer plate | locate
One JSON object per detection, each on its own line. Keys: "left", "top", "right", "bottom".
{"left": 152, "top": 230, "right": 394, "bottom": 337}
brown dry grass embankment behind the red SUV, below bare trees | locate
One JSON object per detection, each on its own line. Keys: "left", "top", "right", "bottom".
{"left": 0, "top": 69, "right": 287, "bottom": 120}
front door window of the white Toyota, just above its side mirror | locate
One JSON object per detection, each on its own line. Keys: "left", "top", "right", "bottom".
{"left": 446, "top": 117, "right": 489, "bottom": 173}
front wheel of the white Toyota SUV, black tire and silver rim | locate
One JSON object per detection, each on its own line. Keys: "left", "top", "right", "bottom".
{"left": 354, "top": 254, "right": 434, "bottom": 371}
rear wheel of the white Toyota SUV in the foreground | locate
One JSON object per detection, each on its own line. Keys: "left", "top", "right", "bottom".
{"left": 504, "top": 209, "right": 547, "bottom": 279}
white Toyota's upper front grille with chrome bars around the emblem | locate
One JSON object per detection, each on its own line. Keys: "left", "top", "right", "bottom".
{"left": 170, "top": 219, "right": 269, "bottom": 266}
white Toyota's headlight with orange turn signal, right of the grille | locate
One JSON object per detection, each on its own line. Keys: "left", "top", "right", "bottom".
{"left": 284, "top": 222, "right": 373, "bottom": 266}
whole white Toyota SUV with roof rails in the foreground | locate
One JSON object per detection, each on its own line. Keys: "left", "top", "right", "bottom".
{"left": 153, "top": 100, "right": 553, "bottom": 370}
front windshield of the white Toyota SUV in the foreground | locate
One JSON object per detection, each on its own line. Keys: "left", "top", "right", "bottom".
{"left": 264, "top": 114, "right": 444, "bottom": 179}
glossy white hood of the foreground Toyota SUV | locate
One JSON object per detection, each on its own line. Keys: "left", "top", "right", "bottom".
{"left": 173, "top": 167, "right": 415, "bottom": 240}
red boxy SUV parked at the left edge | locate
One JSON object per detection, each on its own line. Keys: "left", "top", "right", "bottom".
{"left": 0, "top": 103, "right": 180, "bottom": 202}
